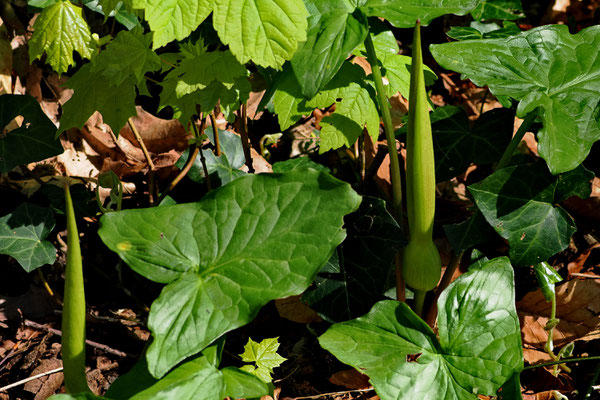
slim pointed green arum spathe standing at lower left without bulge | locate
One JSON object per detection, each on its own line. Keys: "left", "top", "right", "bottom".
{"left": 61, "top": 184, "right": 90, "bottom": 393}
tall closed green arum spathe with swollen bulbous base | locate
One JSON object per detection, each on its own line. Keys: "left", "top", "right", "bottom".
{"left": 403, "top": 21, "right": 441, "bottom": 315}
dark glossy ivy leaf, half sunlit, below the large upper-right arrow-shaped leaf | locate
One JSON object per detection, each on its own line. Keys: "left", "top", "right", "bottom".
{"left": 469, "top": 161, "right": 593, "bottom": 265}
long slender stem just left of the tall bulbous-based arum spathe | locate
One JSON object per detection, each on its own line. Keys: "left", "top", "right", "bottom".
{"left": 365, "top": 27, "right": 402, "bottom": 226}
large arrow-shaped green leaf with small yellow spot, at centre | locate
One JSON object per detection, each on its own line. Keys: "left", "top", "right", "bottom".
{"left": 99, "top": 169, "right": 360, "bottom": 377}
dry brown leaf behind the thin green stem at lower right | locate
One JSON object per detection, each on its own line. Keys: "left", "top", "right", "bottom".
{"left": 517, "top": 277, "right": 600, "bottom": 363}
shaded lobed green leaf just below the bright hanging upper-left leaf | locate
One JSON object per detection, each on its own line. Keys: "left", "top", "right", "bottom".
{"left": 60, "top": 64, "right": 136, "bottom": 134}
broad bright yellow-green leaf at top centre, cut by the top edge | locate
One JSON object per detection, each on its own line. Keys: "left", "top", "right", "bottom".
{"left": 213, "top": 0, "right": 308, "bottom": 68}
